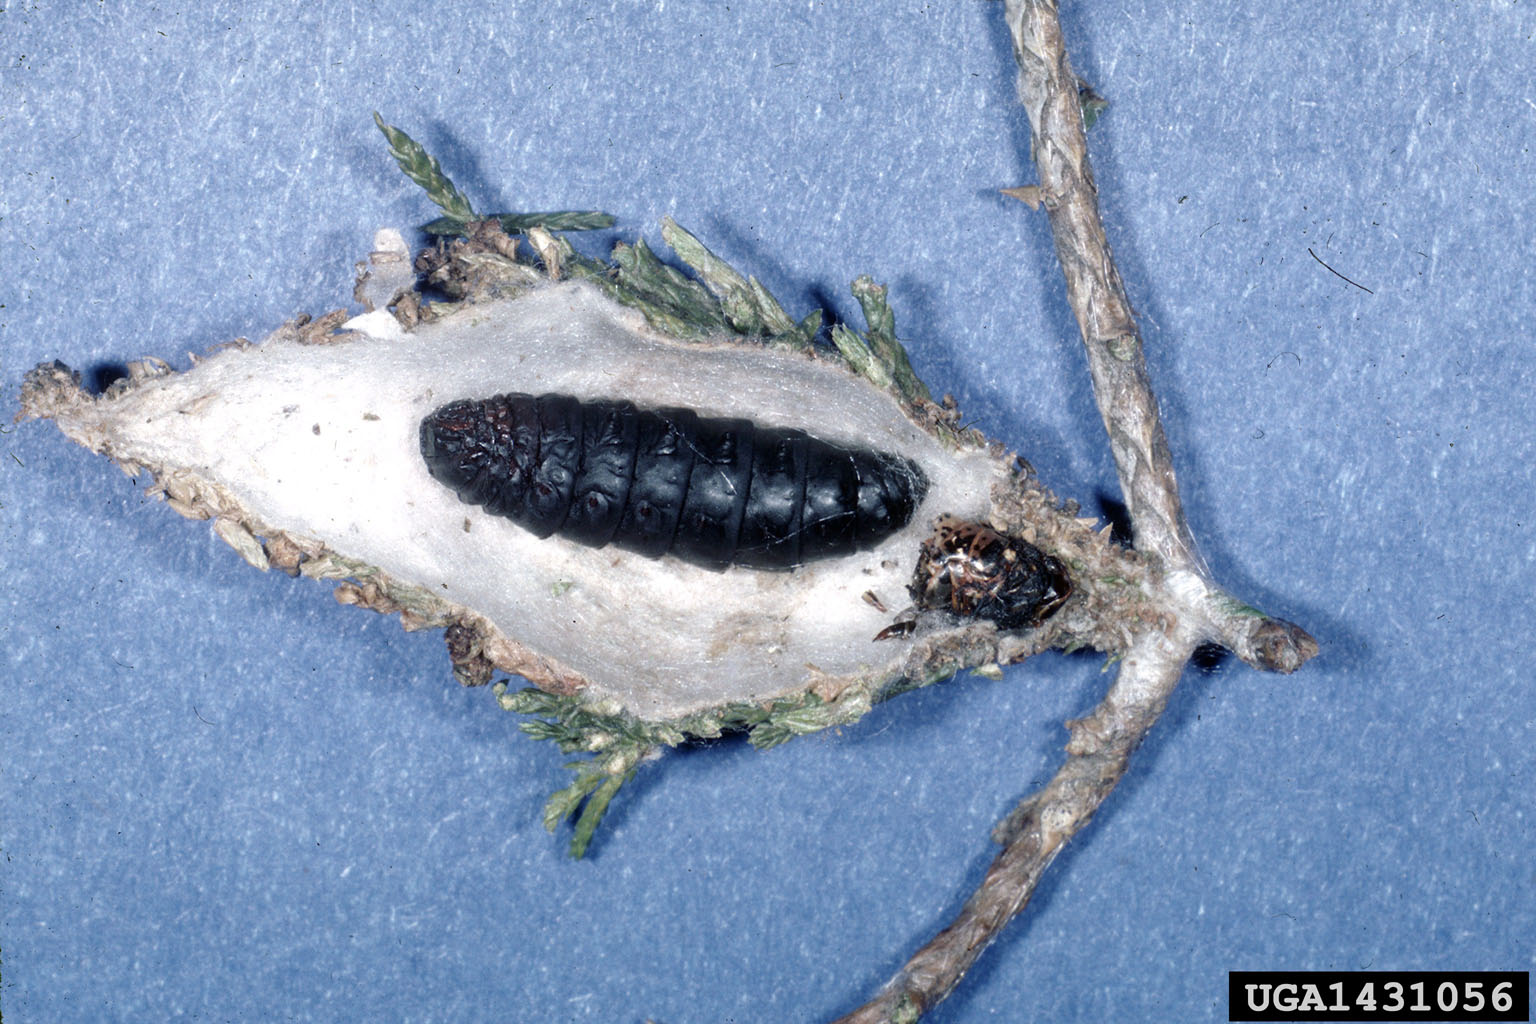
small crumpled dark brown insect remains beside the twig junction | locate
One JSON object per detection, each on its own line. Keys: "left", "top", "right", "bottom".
{"left": 911, "top": 516, "right": 1072, "bottom": 629}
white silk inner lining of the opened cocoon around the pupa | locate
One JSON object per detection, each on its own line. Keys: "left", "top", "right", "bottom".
{"left": 51, "top": 282, "right": 1001, "bottom": 720}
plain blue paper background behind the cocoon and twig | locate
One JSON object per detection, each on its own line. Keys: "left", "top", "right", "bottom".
{"left": 0, "top": 0, "right": 1536, "bottom": 1024}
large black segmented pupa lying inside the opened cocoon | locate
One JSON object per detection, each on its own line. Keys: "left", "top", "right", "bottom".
{"left": 421, "top": 395, "right": 928, "bottom": 570}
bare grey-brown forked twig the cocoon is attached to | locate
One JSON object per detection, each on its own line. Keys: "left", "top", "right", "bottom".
{"left": 839, "top": 0, "right": 1318, "bottom": 1024}
